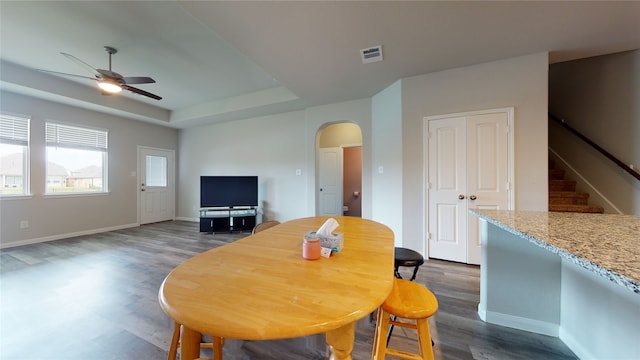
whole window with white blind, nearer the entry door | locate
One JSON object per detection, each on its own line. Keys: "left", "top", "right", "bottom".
{"left": 45, "top": 122, "right": 107, "bottom": 194}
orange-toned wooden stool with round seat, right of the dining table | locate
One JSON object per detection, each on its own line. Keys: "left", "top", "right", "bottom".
{"left": 371, "top": 279, "right": 438, "bottom": 360}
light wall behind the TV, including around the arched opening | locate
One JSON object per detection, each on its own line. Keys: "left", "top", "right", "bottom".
{"left": 177, "top": 99, "right": 371, "bottom": 221}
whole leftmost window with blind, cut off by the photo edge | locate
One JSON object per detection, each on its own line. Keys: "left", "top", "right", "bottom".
{"left": 0, "top": 114, "right": 29, "bottom": 196}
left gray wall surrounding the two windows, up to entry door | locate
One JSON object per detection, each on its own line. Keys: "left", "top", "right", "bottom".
{"left": 0, "top": 92, "right": 178, "bottom": 247}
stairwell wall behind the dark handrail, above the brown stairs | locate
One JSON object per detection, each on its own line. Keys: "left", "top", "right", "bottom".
{"left": 549, "top": 50, "right": 640, "bottom": 215}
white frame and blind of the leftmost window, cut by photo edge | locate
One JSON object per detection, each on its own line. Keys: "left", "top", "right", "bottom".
{"left": 0, "top": 113, "right": 31, "bottom": 197}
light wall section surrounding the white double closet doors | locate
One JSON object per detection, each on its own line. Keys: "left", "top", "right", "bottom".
{"left": 401, "top": 53, "right": 548, "bottom": 253}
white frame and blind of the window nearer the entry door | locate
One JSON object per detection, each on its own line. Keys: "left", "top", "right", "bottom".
{"left": 44, "top": 121, "right": 109, "bottom": 196}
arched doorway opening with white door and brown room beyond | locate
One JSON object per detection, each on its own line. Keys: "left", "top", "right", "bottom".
{"left": 316, "top": 123, "right": 362, "bottom": 217}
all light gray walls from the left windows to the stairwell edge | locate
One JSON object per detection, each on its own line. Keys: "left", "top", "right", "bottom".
{"left": 1, "top": 53, "right": 548, "bottom": 253}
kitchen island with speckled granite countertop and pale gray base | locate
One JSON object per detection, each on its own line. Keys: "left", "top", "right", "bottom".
{"left": 471, "top": 210, "right": 640, "bottom": 359}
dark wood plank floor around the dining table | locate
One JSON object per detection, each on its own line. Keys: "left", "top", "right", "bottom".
{"left": 0, "top": 221, "right": 576, "bottom": 360}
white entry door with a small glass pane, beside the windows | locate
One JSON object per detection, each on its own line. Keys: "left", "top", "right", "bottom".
{"left": 138, "top": 147, "right": 175, "bottom": 224}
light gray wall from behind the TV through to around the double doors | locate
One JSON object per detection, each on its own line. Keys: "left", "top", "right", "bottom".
{"left": 178, "top": 53, "right": 548, "bottom": 253}
